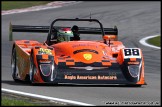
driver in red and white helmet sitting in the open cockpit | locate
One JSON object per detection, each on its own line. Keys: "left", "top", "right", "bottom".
{"left": 57, "top": 28, "right": 73, "bottom": 42}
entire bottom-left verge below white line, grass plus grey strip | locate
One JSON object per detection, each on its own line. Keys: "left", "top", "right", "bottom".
{"left": 1, "top": 92, "right": 72, "bottom": 106}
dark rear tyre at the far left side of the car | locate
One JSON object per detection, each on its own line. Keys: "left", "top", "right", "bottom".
{"left": 11, "top": 48, "right": 18, "bottom": 82}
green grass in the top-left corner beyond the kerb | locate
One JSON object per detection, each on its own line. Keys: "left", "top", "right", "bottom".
{"left": 1, "top": 1, "right": 51, "bottom": 10}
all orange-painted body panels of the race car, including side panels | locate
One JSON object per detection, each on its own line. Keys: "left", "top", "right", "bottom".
{"left": 15, "top": 40, "right": 145, "bottom": 84}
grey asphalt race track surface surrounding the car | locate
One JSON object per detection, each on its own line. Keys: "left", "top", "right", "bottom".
{"left": 1, "top": 1, "right": 161, "bottom": 105}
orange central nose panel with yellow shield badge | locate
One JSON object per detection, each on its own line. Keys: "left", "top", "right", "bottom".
{"left": 52, "top": 41, "right": 124, "bottom": 66}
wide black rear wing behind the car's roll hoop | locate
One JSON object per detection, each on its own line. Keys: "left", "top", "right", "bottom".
{"left": 9, "top": 23, "right": 118, "bottom": 41}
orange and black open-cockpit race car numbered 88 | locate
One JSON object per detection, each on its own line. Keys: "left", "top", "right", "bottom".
{"left": 9, "top": 18, "right": 146, "bottom": 86}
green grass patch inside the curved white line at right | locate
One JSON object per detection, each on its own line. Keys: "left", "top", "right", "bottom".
{"left": 147, "top": 36, "right": 161, "bottom": 47}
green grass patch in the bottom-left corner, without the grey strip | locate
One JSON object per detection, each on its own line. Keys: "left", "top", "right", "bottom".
{"left": 1, "top": 97, "right": 40, "bottom": 106}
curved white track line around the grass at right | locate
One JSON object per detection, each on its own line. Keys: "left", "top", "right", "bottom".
{"left": 139, "top": 35, "right": 161, "bottom": 49}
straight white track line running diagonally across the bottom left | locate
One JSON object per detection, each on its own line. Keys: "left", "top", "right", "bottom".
{"left": 1, "top": 88, "right": 94, "bottom": 106}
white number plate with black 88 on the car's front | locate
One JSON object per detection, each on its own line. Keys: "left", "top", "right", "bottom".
{"left": 124, "top": 48, "right": 141, "bottom": 58}
